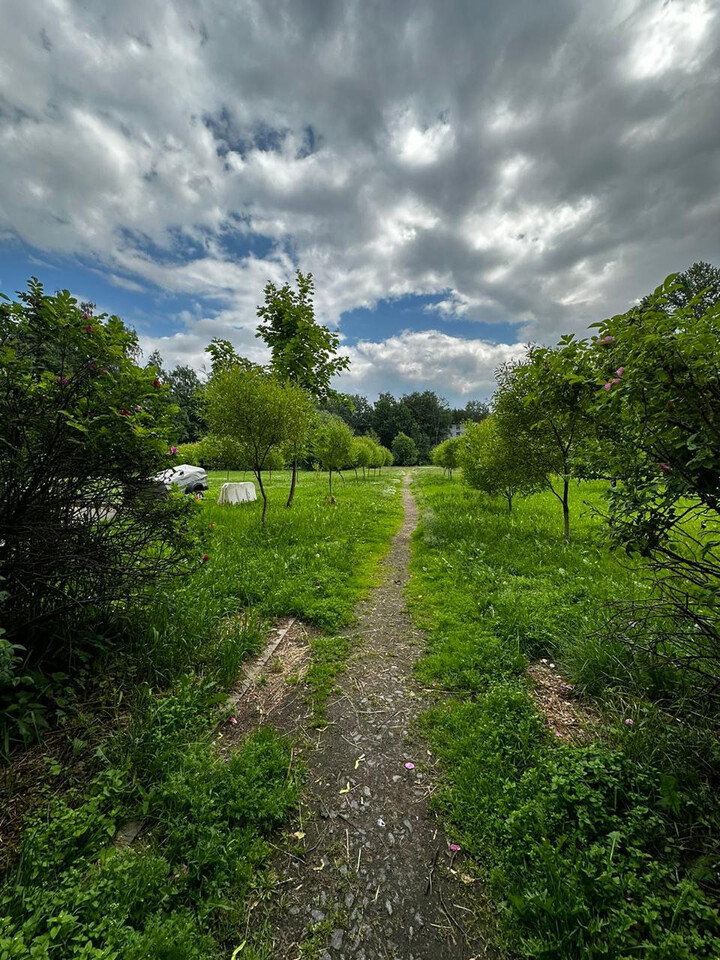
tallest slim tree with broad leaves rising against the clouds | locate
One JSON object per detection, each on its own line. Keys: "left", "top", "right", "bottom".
{"left": 256, "top": 270, "right": 350, "bottom": 507}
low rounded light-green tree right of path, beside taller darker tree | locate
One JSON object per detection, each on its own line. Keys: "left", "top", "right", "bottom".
{"left": 458, "top": 417, "right": 546, "bottom": 511}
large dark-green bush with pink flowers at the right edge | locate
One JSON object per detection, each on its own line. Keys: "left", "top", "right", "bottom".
{"left": 591, "top": 265, "right": 720, "bottom": 697}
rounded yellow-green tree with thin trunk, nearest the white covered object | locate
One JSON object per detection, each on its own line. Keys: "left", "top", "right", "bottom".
{"left": 206, "top": 364, "right": 312, "bottom": 524}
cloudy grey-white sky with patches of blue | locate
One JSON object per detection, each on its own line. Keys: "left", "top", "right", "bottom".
{"left": 0, "top": 0, "right": 720, "bottom": 404}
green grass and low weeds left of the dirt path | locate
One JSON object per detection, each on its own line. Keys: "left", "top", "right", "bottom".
{"left": 0, "top": 471, "right": 402, "bottom": 960}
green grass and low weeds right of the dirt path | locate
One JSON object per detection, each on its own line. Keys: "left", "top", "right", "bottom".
{"left": 409, "top": 470, "right": 720, "bottom": 960}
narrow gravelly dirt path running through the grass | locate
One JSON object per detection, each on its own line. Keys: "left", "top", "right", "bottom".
{"left": 258, "top": 478, "right": 490, "bottom": 960}
